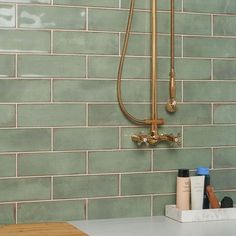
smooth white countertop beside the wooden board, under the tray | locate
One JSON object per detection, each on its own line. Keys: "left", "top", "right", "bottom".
{"left": 69, "top": 216, "right": 236, "bottom": 236}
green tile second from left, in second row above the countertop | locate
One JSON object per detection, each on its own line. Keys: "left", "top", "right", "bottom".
{"left": 53, "top": 175, "right": 118, "bottom": 199}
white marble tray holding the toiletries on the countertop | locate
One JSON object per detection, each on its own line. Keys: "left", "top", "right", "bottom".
{"left": 165, "top": 205, "right": 236, "bottom": 222}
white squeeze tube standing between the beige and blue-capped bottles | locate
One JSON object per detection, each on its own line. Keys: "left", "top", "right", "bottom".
{"left": 190, "top": 176, "right": 205, "bottom": 210}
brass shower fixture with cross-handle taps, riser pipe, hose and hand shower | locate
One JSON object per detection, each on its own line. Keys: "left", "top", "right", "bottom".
{"left": 117, "top": 0, "right": 180, "bottom": 145}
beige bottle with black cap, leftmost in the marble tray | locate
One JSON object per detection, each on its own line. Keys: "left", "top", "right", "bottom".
{"left": 176, "top": 169, "right": 190, "bottom": 210}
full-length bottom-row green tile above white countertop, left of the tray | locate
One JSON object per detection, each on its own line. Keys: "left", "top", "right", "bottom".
{"left": 88, "top": 197, "right": 151, "bottom": 219}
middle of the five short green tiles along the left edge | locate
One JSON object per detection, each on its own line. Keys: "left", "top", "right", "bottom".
{"left": 0, "top": 105, "right": 16, "bottom": 127}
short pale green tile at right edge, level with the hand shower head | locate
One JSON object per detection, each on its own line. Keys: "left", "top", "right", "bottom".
{"left": 214, "top": 104, "right": 236, "bottom": 124}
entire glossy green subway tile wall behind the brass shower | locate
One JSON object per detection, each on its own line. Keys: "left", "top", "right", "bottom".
{"left": 0, "top": 0, "right": 236, "bottom": 224}
